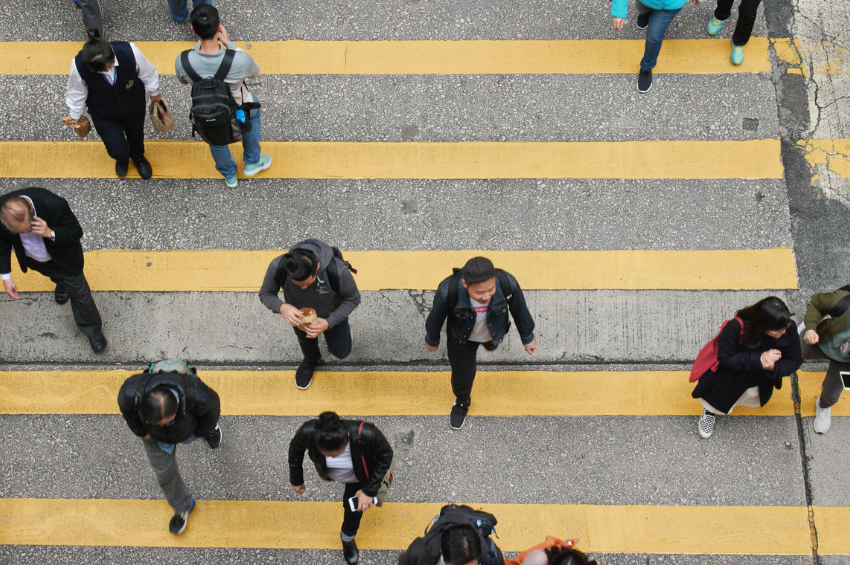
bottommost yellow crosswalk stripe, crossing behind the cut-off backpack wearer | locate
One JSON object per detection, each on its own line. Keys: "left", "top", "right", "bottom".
{"left": 0, "top": 498, "right": 811, "bottom": 555}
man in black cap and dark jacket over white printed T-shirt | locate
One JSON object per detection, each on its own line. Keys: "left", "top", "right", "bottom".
{"left": 425, "top": 257, "right": 537, "bottom": 430}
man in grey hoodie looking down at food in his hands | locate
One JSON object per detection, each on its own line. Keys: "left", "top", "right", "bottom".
{"left": 260, "top": 239, "right": 360, "bottom": 390}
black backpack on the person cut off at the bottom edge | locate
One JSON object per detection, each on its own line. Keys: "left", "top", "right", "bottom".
{"left": 400, "top": 504, "right": 504, "bottom": 565}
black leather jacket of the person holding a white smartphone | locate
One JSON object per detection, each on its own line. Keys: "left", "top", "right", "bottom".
{"left": 289, "top": 420, "right": 393, "bottom": 496}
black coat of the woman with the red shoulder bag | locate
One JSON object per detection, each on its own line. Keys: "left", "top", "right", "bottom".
{"left": 692, "top": 319, "right": 803, "bottom": 414}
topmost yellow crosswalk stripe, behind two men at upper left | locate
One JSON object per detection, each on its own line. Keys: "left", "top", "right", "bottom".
{"left": 0, "top": 37, "right": 771, "bottom": 75}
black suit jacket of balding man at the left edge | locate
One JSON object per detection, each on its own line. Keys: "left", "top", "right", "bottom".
{"left": 0, "top": 187, "right": 84, "bottom": 275}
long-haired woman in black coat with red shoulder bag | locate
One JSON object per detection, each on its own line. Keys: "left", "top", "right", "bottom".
{"left": 692, "top": 296, "right": 803, "bottom": 439}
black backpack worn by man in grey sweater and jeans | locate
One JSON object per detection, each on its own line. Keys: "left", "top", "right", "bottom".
{"left": 180, "top": 49, "right": 242, "bottom": 145}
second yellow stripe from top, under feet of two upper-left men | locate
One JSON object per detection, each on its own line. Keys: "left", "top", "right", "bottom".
{"left": 0, "top": 139, "right": 783, "bottom": 178}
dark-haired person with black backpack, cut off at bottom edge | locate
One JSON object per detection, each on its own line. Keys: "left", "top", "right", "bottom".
{"left": 398, "top": 504, "right": 505, "bottom": 565}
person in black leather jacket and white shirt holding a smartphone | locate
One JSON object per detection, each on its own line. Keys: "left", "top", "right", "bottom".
{"left": 289, "top": 412, "right": 393, "bottom": 565}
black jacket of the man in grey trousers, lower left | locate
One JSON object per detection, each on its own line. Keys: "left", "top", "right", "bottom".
{"left": 118, "top": 373, "right": 221, "bottom": 443}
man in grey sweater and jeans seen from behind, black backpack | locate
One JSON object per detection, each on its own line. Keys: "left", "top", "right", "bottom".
{"left": 174, "top": 4, "right": 272, "bottom": 188}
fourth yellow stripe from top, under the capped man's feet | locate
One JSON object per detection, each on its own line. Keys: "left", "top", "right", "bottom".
{"left": 0, "top": 369, "right": 794, "bottom": 416}
